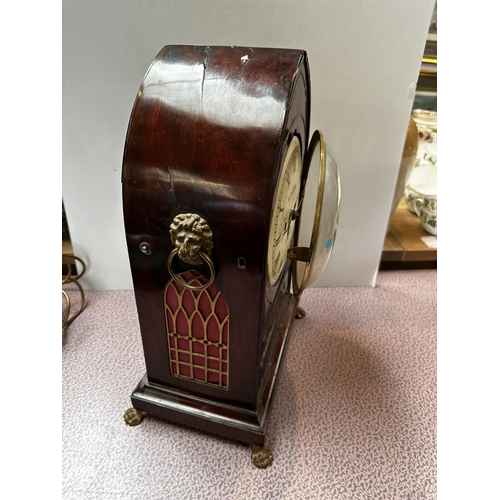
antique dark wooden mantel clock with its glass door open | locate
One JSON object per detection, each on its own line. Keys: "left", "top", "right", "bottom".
{"left": 122, "top": 46, "right": 340, "bottom": 467}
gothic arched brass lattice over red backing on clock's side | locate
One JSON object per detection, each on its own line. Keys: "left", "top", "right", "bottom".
{"left": 164, "top": 270, "right": 229, "bottom": 389}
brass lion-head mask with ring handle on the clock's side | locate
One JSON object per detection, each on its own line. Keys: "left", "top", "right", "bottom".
{"left": 167, "top": 214, "right": 215, "bottom": 290}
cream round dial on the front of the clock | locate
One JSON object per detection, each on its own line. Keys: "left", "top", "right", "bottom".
{"left": 267, "top": 136, "right": 302, "bottom": 285}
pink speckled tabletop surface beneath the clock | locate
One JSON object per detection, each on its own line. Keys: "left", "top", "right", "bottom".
{"left": 62, "top": 270, "right": 437, "bottom": 500}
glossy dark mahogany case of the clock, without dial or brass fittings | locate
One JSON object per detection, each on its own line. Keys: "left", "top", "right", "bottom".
{"left": 122, "top": 46, "right": 310, "bottom": 445}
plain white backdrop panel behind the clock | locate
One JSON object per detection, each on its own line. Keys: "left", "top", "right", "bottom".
{"left": 62, "top": 0, "right": 434, "bottom": 289}
